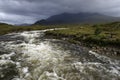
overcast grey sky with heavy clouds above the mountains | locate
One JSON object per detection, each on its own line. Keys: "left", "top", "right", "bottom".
{"left": 0, "top": 0, "right": 120, "bottom": 24}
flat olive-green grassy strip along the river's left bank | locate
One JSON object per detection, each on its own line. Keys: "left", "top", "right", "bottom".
{"left": 0, "top": 23, "right": 63, "bottom": 35}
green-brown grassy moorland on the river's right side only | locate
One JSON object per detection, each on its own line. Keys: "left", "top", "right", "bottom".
{"left": 46, "top": 22, "right": 120, "bottom": 47}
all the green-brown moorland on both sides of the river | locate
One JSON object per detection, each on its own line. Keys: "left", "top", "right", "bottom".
{"left": 0, "top": 22, "right": 120, "bottom": 47}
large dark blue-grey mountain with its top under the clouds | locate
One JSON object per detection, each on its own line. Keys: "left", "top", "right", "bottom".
{"left": 35, "top": 12, "right": 120, "bottom": 24}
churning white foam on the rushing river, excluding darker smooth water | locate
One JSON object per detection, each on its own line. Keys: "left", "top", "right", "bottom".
{"left": 0, "top": 29, "right": 120, "bottom": 80}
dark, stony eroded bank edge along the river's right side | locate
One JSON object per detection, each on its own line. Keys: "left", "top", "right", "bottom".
{"left": 46, "top": 28, "right": 120, "bottom": 59}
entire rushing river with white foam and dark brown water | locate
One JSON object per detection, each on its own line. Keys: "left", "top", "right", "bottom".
{"left": 0, "top": 29, "right": 120, "bottom": 80}
